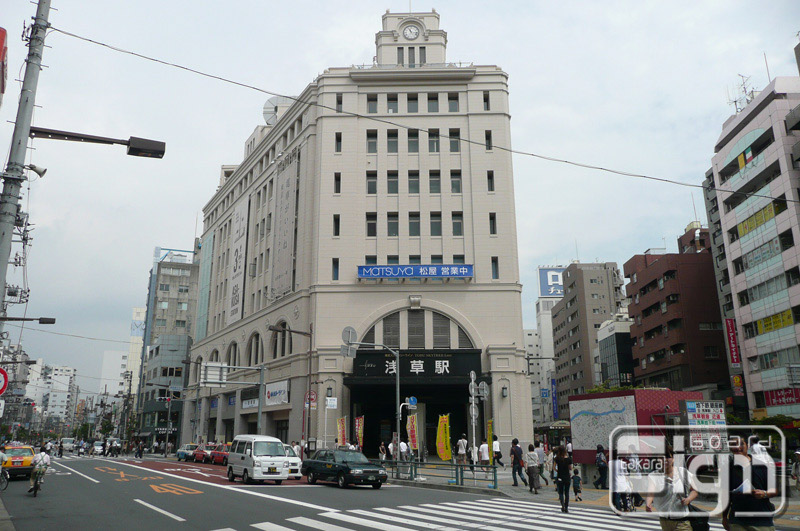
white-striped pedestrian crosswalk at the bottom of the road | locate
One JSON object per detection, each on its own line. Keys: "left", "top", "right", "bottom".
{"left": 251, "top": 498, "right": 723, "bottom": 531}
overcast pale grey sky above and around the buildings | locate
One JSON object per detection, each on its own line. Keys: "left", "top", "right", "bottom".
{"left": 0, "top": 0, "right": 800, "bottom": 389}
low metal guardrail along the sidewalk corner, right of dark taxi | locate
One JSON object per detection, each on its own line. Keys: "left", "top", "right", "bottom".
{"left": 372, "top": 460, "right": 497, "bottom": 489}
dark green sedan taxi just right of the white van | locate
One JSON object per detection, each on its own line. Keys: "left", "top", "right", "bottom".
{"left": 300, "top": 450, "right": 388, "bottom": 489}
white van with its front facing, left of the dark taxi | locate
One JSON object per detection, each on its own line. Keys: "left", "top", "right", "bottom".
{"left": 228, "top": 435, "right": 289, "bottom": 485}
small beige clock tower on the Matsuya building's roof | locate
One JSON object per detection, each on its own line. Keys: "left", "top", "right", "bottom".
{"left": 375, "top": 10, "right": 447, "bottom": 68}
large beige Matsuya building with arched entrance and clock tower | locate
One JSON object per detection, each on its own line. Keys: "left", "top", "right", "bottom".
{"left": 182, "top": 11, "right": 533, "bottom": 455}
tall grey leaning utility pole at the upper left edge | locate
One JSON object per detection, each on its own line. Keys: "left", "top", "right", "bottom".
{"left": 0, "top": 0, "right": 50, "bottom": 332}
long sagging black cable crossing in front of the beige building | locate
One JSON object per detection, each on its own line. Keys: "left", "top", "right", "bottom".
{"left": 50, "top": 26, "right": 800, "bottom": 203}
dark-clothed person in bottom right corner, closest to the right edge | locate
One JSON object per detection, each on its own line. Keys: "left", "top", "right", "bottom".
{"left": 722, "top": 435, "right": 778, "bottom": 531}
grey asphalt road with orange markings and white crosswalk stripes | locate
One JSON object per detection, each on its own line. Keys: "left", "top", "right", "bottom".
{"left": 0, "top": 456, "right": 721, "bottom": 531}
